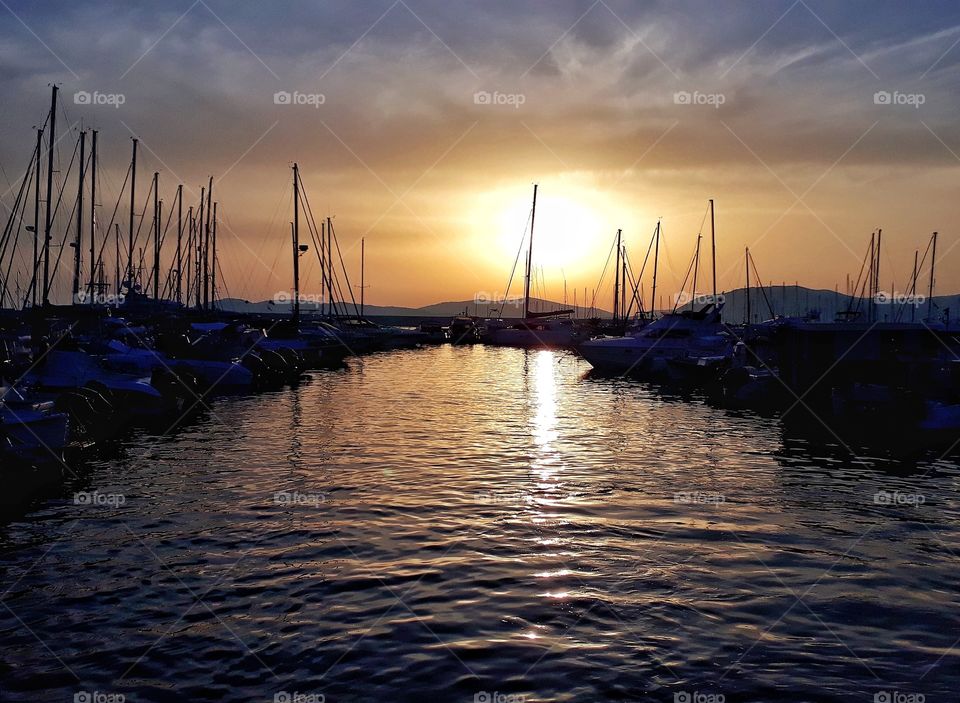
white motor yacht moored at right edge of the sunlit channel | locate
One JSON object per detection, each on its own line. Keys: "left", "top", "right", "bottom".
{"left": 578, "top": 303, "right": 733, "bottom": 376}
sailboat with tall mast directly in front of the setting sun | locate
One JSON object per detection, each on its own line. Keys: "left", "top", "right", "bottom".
{"left": 482, "top": 184, "right": 584, "bottom": 348}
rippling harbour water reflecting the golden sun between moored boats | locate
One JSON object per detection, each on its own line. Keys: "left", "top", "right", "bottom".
{"left": 0, "top": 346, "right": 960, "bottom": 703}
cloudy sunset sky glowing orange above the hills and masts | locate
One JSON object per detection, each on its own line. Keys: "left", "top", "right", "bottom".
{"left": 0, "top": 0, "right": 960, "bottom": 305}
